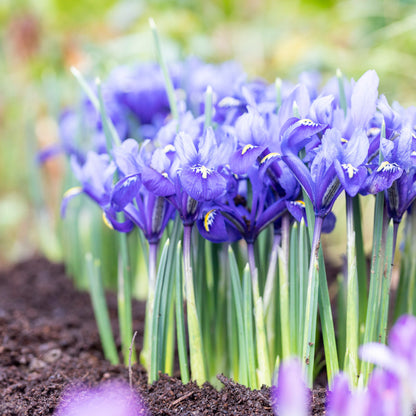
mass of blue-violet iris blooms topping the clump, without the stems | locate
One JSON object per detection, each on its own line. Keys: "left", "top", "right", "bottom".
{"left": 60, "top": 59, "right": 416, "bottom": 247}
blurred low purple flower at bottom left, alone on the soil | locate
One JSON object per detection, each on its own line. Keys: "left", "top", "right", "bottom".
{"left": 54, "top": 382, "right": 149, "bottom": 416}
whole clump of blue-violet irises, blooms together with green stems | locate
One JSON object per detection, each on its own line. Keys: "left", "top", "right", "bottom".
{"left": 56, "top": 25, "right": 416, "bottom": 400}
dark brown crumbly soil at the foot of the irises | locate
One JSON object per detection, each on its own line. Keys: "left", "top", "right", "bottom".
{"left": 0, "top": 259, "right": 325, "bottom": 416}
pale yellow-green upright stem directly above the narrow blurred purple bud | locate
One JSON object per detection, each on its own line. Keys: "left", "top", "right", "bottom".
{"left": 279, "top": 214, "right": 291, "bottom": 360}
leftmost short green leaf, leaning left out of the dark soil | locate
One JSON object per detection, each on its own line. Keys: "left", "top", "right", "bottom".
{"left": 85, "top": 253, "right": 119, "bottom": 365}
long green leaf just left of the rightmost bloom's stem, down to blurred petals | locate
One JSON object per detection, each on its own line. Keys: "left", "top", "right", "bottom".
{"left": 360, "top": 192, "right": 385, "bottom": 385}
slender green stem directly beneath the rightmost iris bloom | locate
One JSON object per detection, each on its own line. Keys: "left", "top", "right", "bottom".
{"left": 377, "top": 222, "right": 399, "bottom": 344}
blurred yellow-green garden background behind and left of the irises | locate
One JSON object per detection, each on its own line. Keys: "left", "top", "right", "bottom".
{"left": 0, "top": 0, "right": 416, "bottom": 264}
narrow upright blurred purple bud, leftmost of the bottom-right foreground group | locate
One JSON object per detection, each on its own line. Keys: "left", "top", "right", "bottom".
{"left": 272, "top": 358, "right": 311, "bottom": 416}
